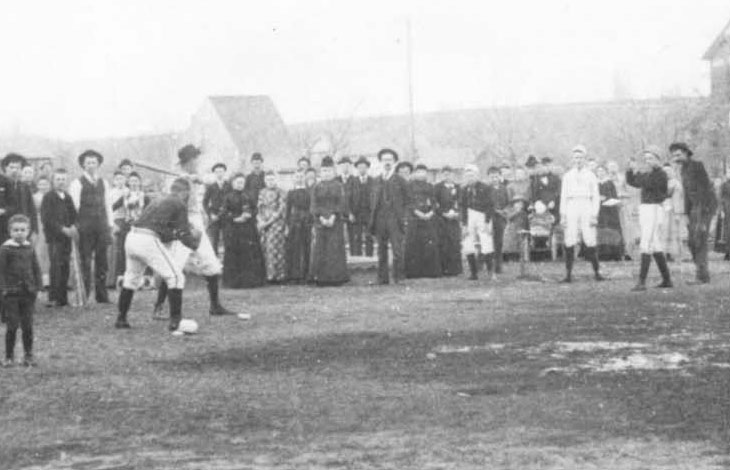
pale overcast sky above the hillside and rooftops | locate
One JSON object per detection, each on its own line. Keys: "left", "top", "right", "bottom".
{"left": 0, "top": 0, "right": 730, "bottom": 139}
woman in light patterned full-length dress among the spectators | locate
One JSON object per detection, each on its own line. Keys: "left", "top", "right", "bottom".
{"left": 256, "top": 170, "right": 286, "bottom": 283}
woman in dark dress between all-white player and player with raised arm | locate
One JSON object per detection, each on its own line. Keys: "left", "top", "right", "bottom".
{"left": 596, "top": 166, "right": 624, "bottom": 261}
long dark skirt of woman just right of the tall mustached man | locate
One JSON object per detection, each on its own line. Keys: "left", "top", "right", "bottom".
{"left": 405, "top": 217, "right": 441, "bottom": 279}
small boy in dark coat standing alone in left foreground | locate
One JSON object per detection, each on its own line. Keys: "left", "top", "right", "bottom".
{"left": 0, "top": 214, "right": 43, "bottom": 367}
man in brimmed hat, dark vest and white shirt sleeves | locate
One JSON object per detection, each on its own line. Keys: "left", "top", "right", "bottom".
{"left": 68, "top": 150, "right": 114, "bottom": 303}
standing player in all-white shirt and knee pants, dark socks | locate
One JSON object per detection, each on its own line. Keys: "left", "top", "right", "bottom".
{"left": 560, "top": 145, "right": 603, "bottom": 282}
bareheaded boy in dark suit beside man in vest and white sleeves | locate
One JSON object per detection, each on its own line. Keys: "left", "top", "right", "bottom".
{"left": 41, "top": 168, "right": 76, "bottom": 307}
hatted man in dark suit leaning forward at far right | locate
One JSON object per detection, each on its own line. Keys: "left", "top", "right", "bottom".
{"left": 669, "top": 142, "right": 717, "bottom": 284}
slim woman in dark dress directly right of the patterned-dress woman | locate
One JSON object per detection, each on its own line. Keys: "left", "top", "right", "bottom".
{"left": 286, "top": 172, "right": 312, "bottom": 283}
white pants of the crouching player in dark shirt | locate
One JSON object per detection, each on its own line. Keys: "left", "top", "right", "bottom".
{"left": 123, "top": 228, "right": 185, "bottom": 290}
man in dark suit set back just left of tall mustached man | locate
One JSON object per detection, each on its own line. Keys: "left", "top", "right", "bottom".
{"left": 350, "top": 157, "right": 373, "bottom": 257}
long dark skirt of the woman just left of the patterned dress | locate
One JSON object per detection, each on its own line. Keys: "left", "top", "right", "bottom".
{"left": 223, "top": 220, "right": 266, "bottom": 289}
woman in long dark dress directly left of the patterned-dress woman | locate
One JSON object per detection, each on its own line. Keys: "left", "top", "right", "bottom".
{"left": 221, "top": 173, "right": 266, "bottom": 289}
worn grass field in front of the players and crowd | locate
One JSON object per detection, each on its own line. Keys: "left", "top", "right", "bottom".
{"left": 0, "top": 261, "right": 730, "bottom": 470}
